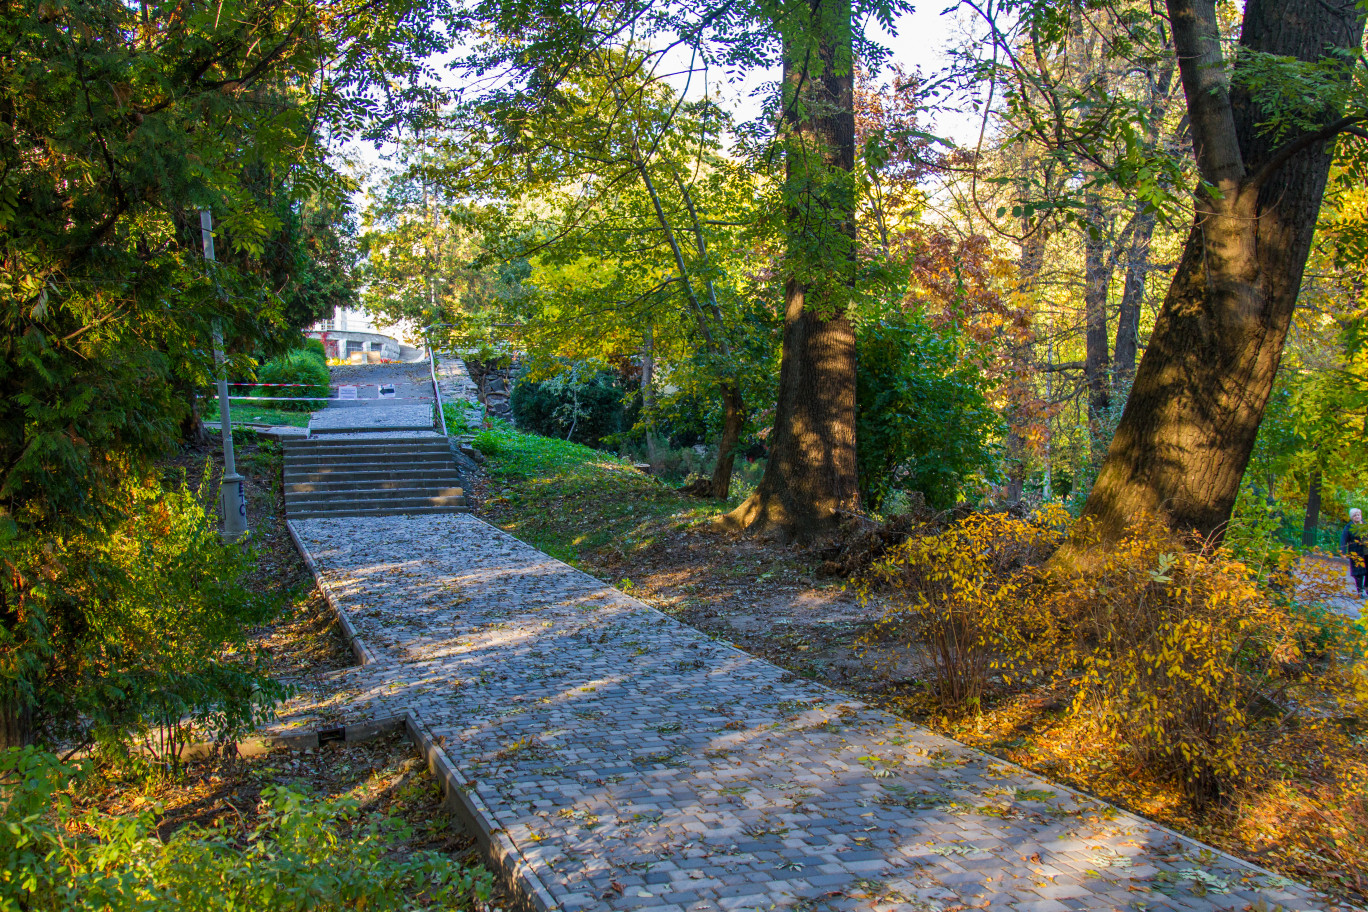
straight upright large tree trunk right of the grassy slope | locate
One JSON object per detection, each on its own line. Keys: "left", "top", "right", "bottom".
{"left": 728, "top": 0, "right": 859, "bottom": 539}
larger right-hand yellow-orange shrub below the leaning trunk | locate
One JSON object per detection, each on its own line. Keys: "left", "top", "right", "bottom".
{"left": 1052, "top": 517, "right": 1362, "bottom": 805}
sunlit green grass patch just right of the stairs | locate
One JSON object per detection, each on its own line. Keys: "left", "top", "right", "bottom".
{"left": 473, "top": 421, "right": 729, "bottom": 565}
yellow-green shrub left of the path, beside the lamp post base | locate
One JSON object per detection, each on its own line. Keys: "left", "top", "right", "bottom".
{"left": 0, "top": 473, "right": 286, "bottom": 762}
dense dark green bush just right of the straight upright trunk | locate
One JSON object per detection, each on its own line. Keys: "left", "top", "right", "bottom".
{"left": 856, "top": 312, "right": 999, "bottom": 509}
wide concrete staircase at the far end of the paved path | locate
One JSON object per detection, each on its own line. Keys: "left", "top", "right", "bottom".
{"left": 285, "top": 436, "right": 471, "bottom": 520}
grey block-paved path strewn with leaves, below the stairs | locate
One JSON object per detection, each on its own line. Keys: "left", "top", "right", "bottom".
{"left": 287, "top": 515, "right": 1334, "bottom": 912}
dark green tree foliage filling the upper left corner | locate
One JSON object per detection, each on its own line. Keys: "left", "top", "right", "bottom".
{"left": 0, "top": 0, "right": 436, "bottom": 533}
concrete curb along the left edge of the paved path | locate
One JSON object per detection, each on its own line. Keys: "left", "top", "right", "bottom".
{"left": 285, "top": 520, "right": 560, "bottom": 912}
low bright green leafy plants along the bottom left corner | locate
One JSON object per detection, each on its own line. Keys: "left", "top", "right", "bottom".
{"left": 0, "top": 748, "right": 492, "bottom": 912}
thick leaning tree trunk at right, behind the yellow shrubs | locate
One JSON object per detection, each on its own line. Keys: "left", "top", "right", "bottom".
{"left": 1085, "top": 0, "right": 1364, "bottom": 537}
